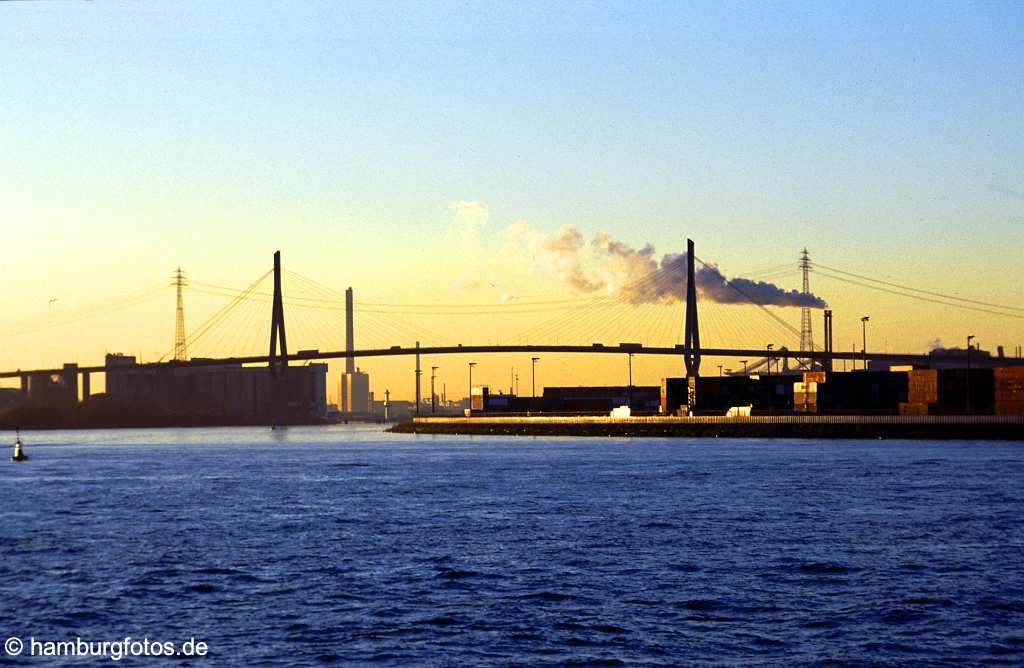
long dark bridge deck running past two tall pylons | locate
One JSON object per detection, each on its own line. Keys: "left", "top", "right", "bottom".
{"left": 0, "top": 343, "right": 1024, "bottom": 378}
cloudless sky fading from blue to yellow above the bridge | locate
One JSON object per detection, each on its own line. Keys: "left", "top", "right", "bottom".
{"left": 0, "top": 2, "right": 1024, "bottom": 396}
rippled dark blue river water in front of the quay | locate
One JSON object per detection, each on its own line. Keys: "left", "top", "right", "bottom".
{"left": 0, "top": 426, "right": 1024, "bottom": 666}
